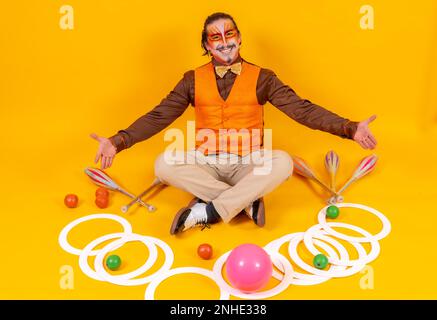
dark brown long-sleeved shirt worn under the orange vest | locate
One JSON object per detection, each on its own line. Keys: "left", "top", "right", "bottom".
{"left": 109, "top": 58, "right": 358, "bottom": 152}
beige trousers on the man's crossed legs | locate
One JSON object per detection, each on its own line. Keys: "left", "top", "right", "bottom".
{"left": 155, "top": 150, "right": 293, "bottom": 223}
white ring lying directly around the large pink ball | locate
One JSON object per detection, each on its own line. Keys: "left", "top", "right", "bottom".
{"left": 213, "top": 251, "right": 294, "bottom": 299}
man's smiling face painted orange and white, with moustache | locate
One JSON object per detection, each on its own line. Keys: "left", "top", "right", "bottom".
{"left": 206, "top": 19, "right": 241, "bottom": 65}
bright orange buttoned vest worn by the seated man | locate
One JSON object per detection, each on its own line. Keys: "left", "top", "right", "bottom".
{"left": 194, "top": 61, "right": 264, "bottom": 156}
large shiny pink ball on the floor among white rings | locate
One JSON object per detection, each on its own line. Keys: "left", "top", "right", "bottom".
{"left": 226, "top": 243, "right": 273, "bottom": 292}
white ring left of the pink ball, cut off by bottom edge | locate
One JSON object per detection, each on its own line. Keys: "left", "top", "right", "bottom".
{"left": 144, "top": 267, "right": 229, "bottom": 300}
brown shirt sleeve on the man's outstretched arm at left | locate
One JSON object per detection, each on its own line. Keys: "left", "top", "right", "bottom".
{"left": 109, "top": 73, "right": 190, "bottom": 153}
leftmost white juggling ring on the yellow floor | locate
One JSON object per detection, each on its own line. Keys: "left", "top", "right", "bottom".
{"left": 58, "top": 213, "right": 132, "bottom": 256}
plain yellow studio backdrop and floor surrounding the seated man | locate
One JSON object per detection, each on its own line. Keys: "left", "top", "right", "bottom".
{"left": 0, "top": 0, "right": 437, "bottom": 299}
